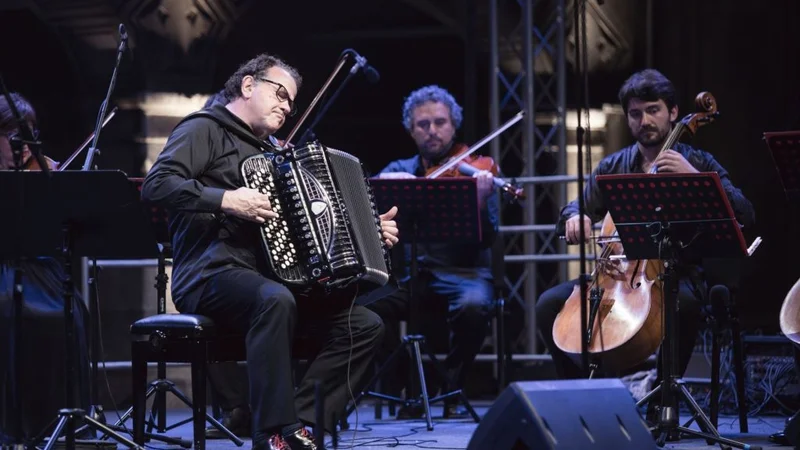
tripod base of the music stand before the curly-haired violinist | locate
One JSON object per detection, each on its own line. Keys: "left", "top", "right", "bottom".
{"left": 346, "top": 335, "right": 480, "bottom": 431}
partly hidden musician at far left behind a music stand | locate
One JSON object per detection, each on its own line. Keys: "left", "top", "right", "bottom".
{"left": 0, "top": 93, "right": 89, "bottom": 440}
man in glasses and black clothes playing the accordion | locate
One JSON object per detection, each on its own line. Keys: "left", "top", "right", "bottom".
{"left": 142, "top": 54, "right": 398, "bottom": 450}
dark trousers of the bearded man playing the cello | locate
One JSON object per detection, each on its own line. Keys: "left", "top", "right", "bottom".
{"left": 536, "top": 278, "right": 705, "bottom": 382}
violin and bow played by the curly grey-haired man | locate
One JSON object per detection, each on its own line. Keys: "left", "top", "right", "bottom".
{"left": 425, "top": 111, "right": 525, "bottom": 200}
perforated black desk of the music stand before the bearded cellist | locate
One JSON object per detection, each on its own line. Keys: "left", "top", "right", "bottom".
{"left": 597, "top": 172, "right": 747, "bottom": 260}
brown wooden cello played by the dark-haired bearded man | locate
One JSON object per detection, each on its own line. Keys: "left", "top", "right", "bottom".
{"left": 553, "top": 92, "right": 719, "bottom": 372}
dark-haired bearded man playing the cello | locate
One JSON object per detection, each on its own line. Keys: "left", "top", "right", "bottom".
{"left": 536, "top": 69, "right": 755, "bottom": 420}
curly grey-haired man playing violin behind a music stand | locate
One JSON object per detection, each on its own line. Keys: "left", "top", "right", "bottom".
{"left": 368, "top": 86, "right": 499, "bottom": 418}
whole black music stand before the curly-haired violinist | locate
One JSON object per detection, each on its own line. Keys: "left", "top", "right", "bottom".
{"left": 347, "top": 178, "right": 481, "bottom": 431}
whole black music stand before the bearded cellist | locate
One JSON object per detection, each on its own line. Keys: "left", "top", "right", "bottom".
{"left": 597, "top": 172, "right": 760, "bottom": 449}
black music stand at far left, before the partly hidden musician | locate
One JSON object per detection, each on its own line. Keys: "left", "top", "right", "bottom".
{"left": 0, "top": 171, "right": 155, "bottom": 450}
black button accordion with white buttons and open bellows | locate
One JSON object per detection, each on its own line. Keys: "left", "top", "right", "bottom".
{"left": 241, "top": 142, "right": 391, "bottom": 287}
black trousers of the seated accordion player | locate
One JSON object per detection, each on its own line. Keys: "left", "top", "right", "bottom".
{"left": 176, "top": 269, "right": 383, "bottom": 439}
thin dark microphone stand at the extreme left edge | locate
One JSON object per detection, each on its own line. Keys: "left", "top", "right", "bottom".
{"left": 0, "top": 75, "right": 52, "bottom": 446}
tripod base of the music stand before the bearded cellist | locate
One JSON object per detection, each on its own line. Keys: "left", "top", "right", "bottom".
{"left": 636, "top": 379, "right": 761, "bottom": 450}
